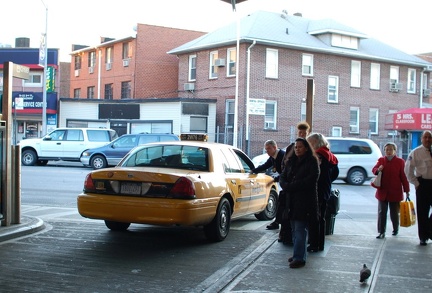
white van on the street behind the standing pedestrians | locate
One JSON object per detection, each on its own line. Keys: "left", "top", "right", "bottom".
{"left": 327, "top": 137, "right": 382, "bottom": 185}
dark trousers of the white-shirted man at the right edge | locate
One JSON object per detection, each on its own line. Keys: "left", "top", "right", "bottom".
{"left": 416, "top": 178, "right": 432, "bottom": 240}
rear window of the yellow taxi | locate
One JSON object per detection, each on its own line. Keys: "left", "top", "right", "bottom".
{"left": 121, "top": 145, "right": 209, "bottom": 171}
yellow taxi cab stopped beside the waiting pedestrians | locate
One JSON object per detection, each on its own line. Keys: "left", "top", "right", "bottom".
{"left": 77, "top": 135, "right": 278, "bottom": 241}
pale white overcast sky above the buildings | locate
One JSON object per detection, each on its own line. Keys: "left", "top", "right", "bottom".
{"left": 0, "top": 0, "right": 432, "bottom": 62}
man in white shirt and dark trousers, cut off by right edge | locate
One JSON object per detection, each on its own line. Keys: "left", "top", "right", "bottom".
{"left": 405, "top": 130, "right": 432, "bottom": 246}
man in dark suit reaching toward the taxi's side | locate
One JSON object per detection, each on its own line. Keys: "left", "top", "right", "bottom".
{"left": 250, "top": 140, "right": 285, "bottom": 230}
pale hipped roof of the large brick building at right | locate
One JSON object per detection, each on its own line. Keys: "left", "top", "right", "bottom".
{"left": 168, "top": 11, "right": 432, "bottom": 70}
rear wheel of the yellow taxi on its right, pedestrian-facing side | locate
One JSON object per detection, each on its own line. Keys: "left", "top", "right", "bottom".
{"left": 204, "top": 197, "right": 231, "bottom": 242}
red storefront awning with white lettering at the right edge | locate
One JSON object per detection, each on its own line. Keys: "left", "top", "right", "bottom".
{"left": 384, "top": 108, "right": 432, "bottom": 131}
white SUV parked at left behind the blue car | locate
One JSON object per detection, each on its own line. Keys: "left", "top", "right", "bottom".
{"left": 19, "top": 128, "right": 117, "bottom": 166}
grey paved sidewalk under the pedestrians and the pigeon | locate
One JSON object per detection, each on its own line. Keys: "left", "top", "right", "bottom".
{"left": 214, "top": 215, "right": 432, "bottom": 293}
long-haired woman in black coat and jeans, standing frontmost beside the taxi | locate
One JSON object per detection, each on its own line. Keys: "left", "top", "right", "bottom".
{"left": 279, "top": 138, "right": 320, "bottom": 268}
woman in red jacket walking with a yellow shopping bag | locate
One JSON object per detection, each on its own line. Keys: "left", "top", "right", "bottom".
{"left": 372, "top": 142, "right": 410, "bottom": 239}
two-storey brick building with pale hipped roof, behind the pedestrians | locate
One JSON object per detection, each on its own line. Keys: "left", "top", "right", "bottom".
{"left": 169, "top": 11, "right": 431, "bottom": 156}
